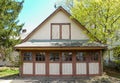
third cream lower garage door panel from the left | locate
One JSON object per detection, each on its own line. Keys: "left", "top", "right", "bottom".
{"left": 49, "top": 63, "right": 60, "bottom": 75}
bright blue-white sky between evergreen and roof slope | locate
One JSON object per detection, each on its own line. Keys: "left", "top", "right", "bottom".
{"left": 18, "top": 0, "right": 60, "bottom": 33}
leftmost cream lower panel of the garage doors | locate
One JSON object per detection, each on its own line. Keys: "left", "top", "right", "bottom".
{"left": 23, "top": 63, "right": 33, "bottom": 74}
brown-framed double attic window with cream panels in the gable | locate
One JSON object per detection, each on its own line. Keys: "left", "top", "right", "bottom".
{"left": 51, "top": 23, "right": 71, "bottom": 40}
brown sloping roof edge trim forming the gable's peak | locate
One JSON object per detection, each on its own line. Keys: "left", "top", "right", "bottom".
{"left": 23, "top": 6, "right": 90, "bottom": 42}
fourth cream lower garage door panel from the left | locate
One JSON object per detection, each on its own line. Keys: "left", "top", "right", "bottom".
{"left": 62, "top": 63, "right": 73, "bottom": 75}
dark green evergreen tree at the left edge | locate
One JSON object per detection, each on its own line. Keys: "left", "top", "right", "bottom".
{"left": 0, "top": 0, "right": 24, "bottom": 64}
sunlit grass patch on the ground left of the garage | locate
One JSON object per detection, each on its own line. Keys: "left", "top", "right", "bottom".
{"left": 0, "top": 67, "right": 19, "bottom": 78}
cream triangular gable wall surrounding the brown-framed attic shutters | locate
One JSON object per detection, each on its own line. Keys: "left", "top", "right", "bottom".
{"left": 29, "top": 11, "right": 88, "bottom": 40}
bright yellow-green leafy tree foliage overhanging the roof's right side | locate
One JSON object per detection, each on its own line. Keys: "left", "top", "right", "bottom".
{"left": 71, "top": 0, "right": 120, "bottom": 44}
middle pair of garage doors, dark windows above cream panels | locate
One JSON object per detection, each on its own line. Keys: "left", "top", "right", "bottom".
{"left": 49, "top": 52, "right": 73, "bottom": 75}
